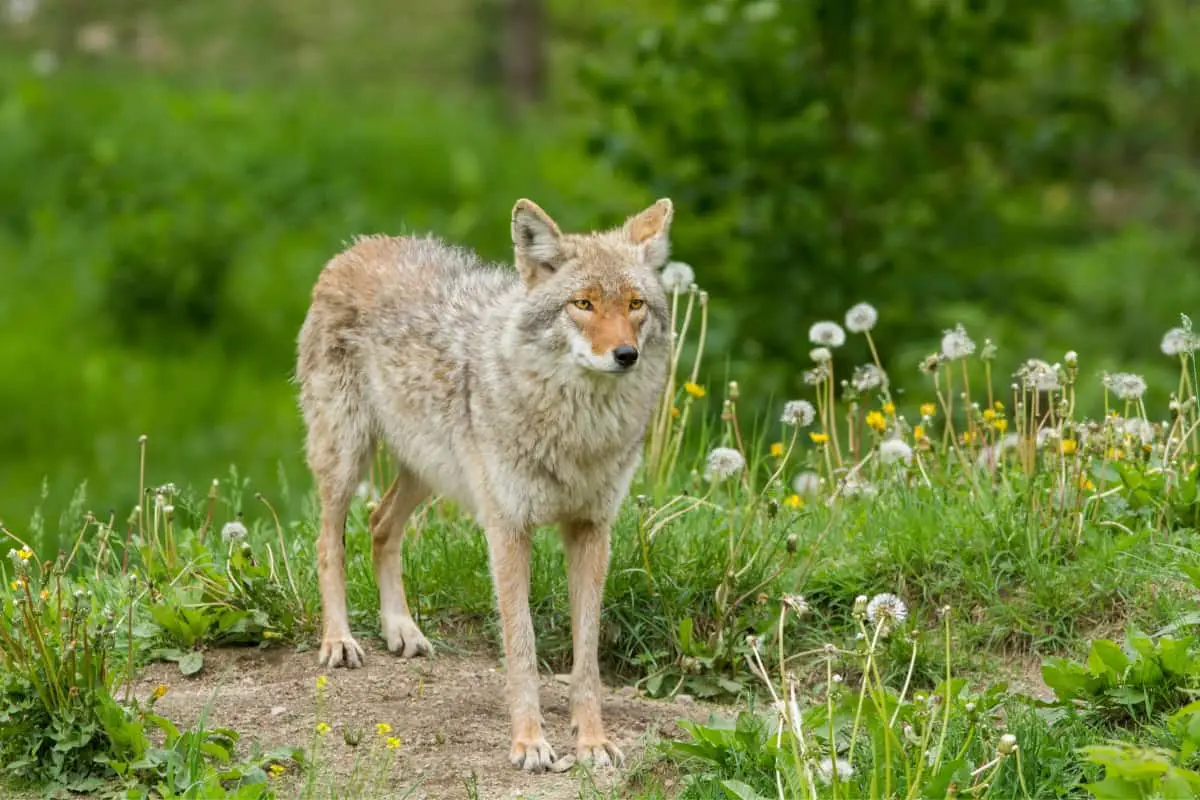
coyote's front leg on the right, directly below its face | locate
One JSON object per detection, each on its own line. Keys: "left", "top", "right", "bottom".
{"left": 563, "top": 523, "right": 625, "bottom": 766}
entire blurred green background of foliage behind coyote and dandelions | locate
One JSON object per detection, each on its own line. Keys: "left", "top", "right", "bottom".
{"left": 0, "top": 0, "right": 1200, "bottom": 532}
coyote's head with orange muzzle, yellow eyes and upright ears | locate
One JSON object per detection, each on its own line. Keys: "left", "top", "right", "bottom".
{"left": 512, "top": 199, "right": 674, "bottom": 374}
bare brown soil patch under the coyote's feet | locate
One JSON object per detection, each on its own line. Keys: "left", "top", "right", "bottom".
{"left": 134, "top": 640, "right": 712, "bottom": 800}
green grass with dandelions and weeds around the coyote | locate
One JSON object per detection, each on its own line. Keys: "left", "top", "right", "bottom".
{"left": 0, "top": 295, "right": 1200, "bottom": 798}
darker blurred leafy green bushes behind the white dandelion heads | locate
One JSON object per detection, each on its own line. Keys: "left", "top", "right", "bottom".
{"left": 584, "top": 0, "right": 1200, "bottom": 401}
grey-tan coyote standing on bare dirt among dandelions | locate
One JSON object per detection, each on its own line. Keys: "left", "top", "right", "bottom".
{"left": 296, "top": 199, "right": 673, "bottom": 771}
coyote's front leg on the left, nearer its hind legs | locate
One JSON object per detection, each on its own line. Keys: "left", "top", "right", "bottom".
{"left": 487, "top": 524, "right": 554, "bottom": 772}
